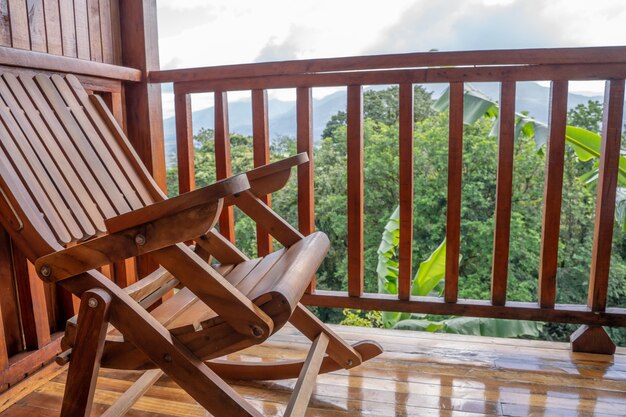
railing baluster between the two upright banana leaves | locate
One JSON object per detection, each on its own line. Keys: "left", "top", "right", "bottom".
{"left": 398, "top": 83, "right": 414, "bottom": 300}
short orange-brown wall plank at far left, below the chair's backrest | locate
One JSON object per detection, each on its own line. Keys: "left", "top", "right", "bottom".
{"left": 13, "top": 248, "right": 51, "bottom": 350}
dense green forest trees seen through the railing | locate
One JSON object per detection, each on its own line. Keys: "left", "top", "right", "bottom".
{"left": 167, "top": 86, "right": 626, "bottom": 345}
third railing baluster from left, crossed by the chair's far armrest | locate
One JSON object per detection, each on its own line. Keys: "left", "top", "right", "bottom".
{"left": 252, "top": 90, "right": 272, "bottom": 256}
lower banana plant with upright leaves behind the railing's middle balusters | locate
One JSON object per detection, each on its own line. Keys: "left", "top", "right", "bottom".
{"left": 376, "top": 207, "right": 543, "bottom": 337}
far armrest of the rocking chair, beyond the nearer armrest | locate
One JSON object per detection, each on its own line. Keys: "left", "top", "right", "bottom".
{"left": 246, "top": 152, "right": 309, "bottom": 197}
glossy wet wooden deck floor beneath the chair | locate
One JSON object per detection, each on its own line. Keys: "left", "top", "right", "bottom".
{"left": 0, "top": 327, "right": 626, "bottom": 417}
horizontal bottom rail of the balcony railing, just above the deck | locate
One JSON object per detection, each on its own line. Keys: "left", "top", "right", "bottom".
{"left": 302, "top": 290, "right": 626, "bottom": 326}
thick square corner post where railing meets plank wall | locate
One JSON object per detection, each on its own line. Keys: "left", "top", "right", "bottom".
{"left": 117, "top": 0, "right": 167, "bottom": 277}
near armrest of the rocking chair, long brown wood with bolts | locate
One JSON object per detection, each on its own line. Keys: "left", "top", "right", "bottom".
{"left": 35, "top": 175, "right": 249, "bottom": 282}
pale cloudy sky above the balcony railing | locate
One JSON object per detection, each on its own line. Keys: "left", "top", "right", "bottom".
{"left": 157, "top": 0, "right": 626, "bottom": 113}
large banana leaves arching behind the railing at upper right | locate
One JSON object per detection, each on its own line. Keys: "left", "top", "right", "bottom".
{"left": 433, "top": 83, "right": 626, "bottom": 231}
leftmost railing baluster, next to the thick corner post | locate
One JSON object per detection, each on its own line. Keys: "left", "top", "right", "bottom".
{"left": 174, "top": 94, "right": 196, "bottom": 194}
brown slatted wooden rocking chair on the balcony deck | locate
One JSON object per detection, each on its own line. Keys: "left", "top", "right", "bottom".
{"left": 0, "top": 73, "right": 382, "bottom": 417}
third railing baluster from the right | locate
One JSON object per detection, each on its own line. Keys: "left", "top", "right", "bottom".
{"left": 491, "top": 81, "right": 515, "bottom": 306}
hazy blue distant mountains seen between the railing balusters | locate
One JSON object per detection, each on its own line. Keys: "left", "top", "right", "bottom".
{"left": 163, "top": 82, "right": 626, "bottom": 164}
